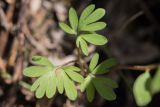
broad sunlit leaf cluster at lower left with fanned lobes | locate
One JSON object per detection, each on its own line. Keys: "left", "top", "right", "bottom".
{"left": 23, "top": 56, "right": 84, "bottom": 100}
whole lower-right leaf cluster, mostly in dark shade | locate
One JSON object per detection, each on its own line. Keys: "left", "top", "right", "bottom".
{"left": 81, "top": 53, "right": 118, "bottom": 102}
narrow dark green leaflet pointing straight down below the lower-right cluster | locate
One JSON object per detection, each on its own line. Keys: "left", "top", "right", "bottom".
{"left": 86, "top": 82, "right": 95, "bottom": 102}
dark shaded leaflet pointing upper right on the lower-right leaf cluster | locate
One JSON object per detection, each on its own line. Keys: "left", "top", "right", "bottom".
{"left": 92, "top": 58, "right": 117, "bottom": 74}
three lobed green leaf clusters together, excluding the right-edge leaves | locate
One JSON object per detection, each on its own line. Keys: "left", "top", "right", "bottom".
{"left": 23, "top": 5, "right": 117, "bottom": 102}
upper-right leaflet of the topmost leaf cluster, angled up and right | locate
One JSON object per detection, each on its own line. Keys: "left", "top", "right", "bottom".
{"left": 85, "top": 8, "right": 105, "bottom": 25}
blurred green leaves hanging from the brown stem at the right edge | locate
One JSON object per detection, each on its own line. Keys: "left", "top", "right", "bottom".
{"left": 133, "top": 67, "right": 160, "bottom": 106}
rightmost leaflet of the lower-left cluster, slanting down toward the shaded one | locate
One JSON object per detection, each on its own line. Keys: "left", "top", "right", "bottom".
{"left": 65, "top": 69, "right": 84, "bottom": 83}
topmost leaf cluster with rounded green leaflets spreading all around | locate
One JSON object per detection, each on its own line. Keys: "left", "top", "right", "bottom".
{"left": 59, "top": 5, "right": 107, "bottom": 56}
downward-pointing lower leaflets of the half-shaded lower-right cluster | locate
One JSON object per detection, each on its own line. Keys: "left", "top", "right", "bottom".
{"left": 81, "top": 75, "right": 118, "bottom": 102}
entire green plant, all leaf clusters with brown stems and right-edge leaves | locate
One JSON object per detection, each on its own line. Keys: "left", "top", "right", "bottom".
{"left": 20, "top": 5, "right": 160, "bottom": 106}
